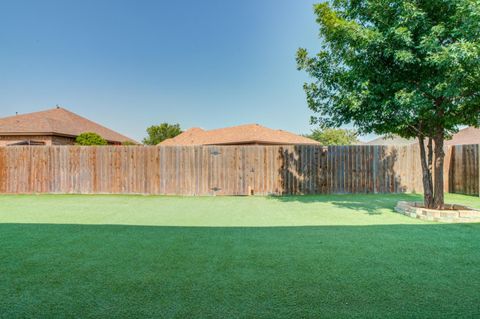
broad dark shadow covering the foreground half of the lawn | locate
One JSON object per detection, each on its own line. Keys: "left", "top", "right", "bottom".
{"left": 0, "top": 224, "right": 480, "bottom": 318}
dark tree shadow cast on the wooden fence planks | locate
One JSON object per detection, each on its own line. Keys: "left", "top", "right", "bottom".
{"left": 278, "top": 145, "right": 406, "bottom": 195}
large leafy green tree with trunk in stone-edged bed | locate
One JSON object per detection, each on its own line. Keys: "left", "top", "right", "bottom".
{"left": 297, "top": 0, "right": 480, "bottom": 209}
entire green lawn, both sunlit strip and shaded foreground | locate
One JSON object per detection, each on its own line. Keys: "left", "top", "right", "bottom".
{"left": 0, "top": 195, "right": 480, "bottom": 318}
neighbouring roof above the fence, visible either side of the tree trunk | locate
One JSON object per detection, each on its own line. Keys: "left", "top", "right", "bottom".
{"left": 365, "top": 127, "right": 480, "bottom": 146}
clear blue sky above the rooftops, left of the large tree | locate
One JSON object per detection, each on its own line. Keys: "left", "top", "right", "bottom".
{"left": 0, "top": 0, "right": 376, "bottom": 140}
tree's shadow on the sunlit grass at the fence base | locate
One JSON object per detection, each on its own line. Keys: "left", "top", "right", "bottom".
{"left": 268, "top": 194, "right": 422, "bottom": 215}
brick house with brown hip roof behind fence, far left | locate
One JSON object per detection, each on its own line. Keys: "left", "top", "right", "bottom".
{"left": 0, "top": 107, "right": 137, "bottom": 146}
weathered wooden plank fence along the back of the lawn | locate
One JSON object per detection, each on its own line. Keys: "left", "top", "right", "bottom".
{"left": 0, "top": 145, "right": 479, "bottom": 195}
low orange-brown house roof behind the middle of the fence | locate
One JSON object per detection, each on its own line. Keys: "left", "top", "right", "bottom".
{"left": 159, "top": 124, "right": 320, "bottom": 146}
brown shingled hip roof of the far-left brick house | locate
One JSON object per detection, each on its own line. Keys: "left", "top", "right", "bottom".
{"left": 0, "top": 107, "right": 137, "bottom": 143}
